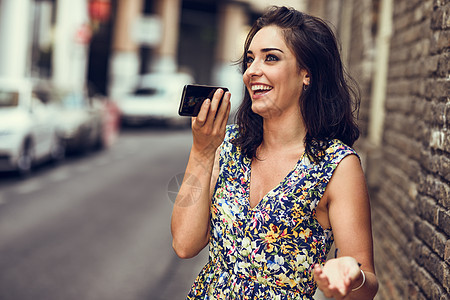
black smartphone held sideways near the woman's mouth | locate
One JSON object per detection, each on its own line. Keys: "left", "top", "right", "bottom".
{"left": 178, "top": 84, "right": 228, "bottom": 117}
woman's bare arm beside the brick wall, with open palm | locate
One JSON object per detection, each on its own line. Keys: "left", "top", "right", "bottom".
{"left": 314, "top": 155, "right": 378, "bottom": 300}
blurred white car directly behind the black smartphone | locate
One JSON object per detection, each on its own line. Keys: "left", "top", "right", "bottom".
{"left": 117, "top": 73, "right": 194, "bottom": 125}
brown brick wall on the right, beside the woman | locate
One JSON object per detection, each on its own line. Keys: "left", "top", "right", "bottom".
{"left": 311, "top": 0, "right": 450, "bottom": 300}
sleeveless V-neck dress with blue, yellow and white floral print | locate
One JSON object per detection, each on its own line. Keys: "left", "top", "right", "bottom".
{"left": 187, "top": 125, "right": 356, "bottom": 300}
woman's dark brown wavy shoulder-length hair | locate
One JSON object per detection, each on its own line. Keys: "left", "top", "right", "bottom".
{"left": 233, "top": 6, "right": 360, "bottom": 161}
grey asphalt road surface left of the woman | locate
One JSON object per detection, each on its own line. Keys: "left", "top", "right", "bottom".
{"left": 0, "top": 129, "right": 207, "bottom": 300}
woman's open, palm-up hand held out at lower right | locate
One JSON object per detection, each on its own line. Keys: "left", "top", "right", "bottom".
{"left": 314, "top": 256, "right": 363, "bottom": 300}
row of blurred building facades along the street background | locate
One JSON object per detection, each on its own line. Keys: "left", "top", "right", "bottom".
{"left": 0, "top": 0, "right": 306, "bottom": 100}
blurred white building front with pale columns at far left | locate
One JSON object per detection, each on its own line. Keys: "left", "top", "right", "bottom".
{"left": 0, "top": 0, "right": 90, "bottom": 88}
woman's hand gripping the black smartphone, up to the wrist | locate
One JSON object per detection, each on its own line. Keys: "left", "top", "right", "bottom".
{"left": 192, "top": 89, "right": 231, "bottom": 155}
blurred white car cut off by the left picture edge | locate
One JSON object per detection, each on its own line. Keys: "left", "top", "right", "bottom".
{"left": 0, "top": 79, "right": 65, "bottom": 175}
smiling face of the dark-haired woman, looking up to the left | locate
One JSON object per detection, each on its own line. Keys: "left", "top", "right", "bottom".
{"left": 243, "top": 25, "right": 309, "bottom": 118}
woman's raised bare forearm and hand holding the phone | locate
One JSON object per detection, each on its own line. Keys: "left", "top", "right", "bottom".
{"left": 171, "top": 90, "right": 231, "bottom": 258}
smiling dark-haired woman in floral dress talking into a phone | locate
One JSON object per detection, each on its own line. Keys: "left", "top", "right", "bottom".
{"left": 172, "top": 7, "right": 378, "bottom": 299}
